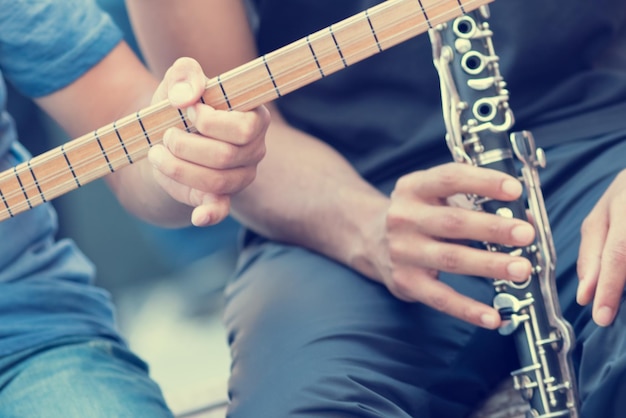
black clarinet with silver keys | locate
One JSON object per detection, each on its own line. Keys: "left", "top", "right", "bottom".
{"left": 429, "top": 6, "right": 579, "bottom": 418}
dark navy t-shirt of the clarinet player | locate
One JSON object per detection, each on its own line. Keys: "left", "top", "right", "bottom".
{"left": 248, "top": 0, "right": 626, "bottom": 191}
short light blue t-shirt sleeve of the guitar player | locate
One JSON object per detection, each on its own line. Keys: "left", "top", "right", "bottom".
{"left": 0, "top": 0, "right": 122, "bottom": 97}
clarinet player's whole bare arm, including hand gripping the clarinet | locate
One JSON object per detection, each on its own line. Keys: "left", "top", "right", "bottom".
{"left": 127, "top": 0, "right": 533, "bottom": 328}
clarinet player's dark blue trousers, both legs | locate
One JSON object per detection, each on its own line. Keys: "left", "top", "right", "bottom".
{"left": 225, "top": 132, "right": 626, "bottom": 418}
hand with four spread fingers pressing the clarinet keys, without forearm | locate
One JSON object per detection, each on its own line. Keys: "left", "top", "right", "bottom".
{"left": 372, "top": 163, "right": 535, "bottom": 329}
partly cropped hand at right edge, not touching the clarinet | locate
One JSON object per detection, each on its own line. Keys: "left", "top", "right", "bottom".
{"left": 577, "top": 170, "right": 626, "bottom": 326}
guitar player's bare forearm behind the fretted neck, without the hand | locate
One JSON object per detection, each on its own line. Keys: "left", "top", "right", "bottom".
{"left": 36, "top": 43, "right": 200, "bottom": 226}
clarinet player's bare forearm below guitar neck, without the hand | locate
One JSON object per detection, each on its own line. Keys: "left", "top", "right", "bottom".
{"left": 233, "top": 111, "right": 388, "bottom": 279}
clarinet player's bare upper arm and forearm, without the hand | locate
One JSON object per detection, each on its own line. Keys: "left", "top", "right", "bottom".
{"left": 126, "top": 0, "right": 388, "bottom": 277}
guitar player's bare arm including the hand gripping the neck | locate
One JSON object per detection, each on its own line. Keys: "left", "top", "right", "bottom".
{"left": 36, "top": 43, "right": 267, "bottom": 226}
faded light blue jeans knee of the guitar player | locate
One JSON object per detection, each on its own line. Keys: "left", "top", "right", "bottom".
{"left": 0, "top": 339, "right": 172, "bottom": 418}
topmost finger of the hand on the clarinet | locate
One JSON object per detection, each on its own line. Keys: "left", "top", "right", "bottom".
{"left": 399, "top": 163, "right": 522, "bottom": 201}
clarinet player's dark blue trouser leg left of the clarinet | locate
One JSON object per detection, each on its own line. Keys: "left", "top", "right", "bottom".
{"left": 225, "top": 242, "right": 515, "bottom": 418}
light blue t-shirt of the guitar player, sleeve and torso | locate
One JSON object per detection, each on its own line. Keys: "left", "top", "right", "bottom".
{"left": 0, "top": 0, "right": 122, "bottom": 355}
